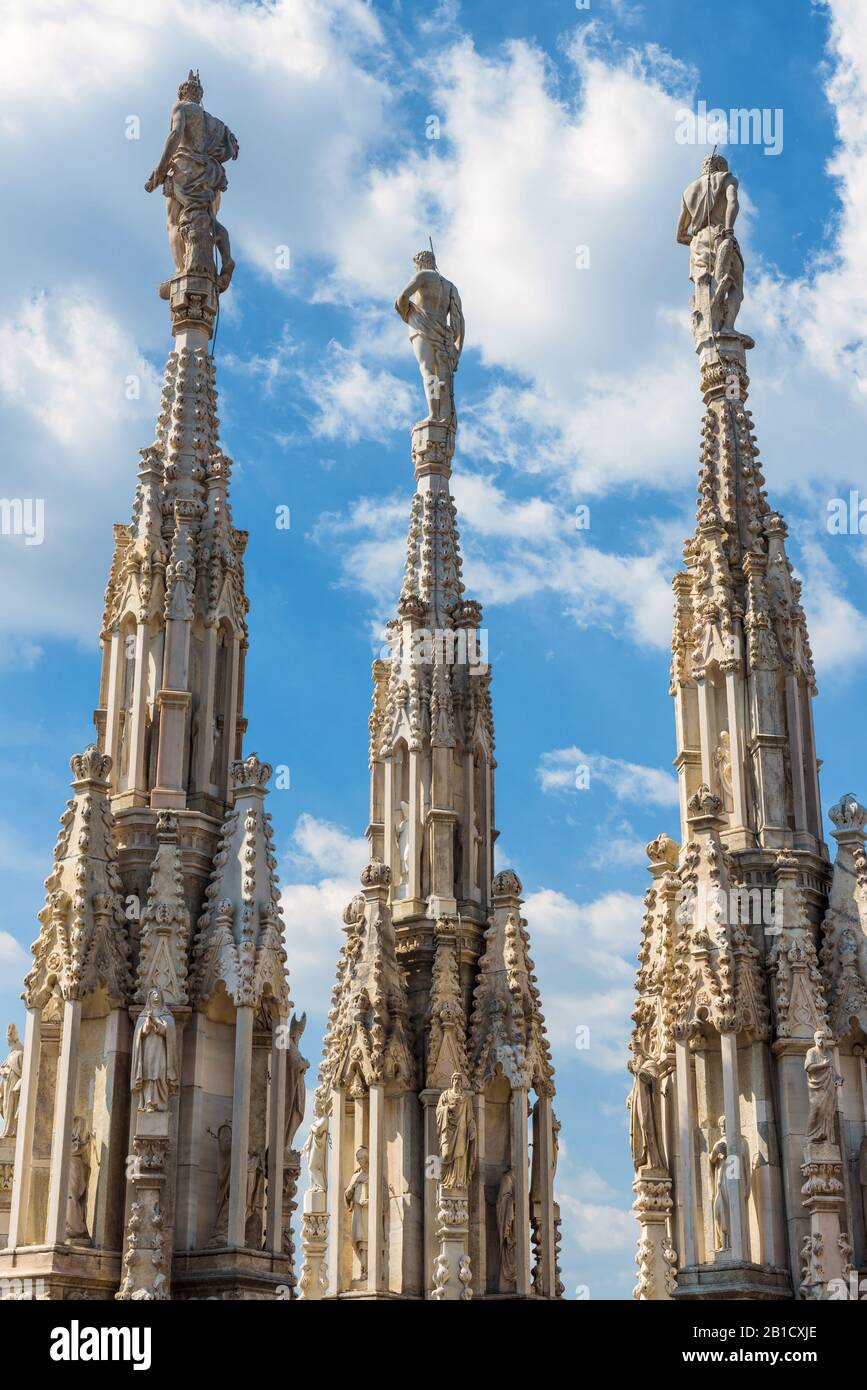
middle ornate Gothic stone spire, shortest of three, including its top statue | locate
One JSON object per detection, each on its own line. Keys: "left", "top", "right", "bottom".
{"left": 302, "top": 252, "right": 560, "bottom": 1301}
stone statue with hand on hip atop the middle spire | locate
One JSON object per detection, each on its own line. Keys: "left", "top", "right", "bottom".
{"left": 395, "top": 252, "right": 464, "bottom": 430}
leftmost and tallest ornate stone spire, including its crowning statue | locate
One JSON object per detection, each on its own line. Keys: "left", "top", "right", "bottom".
{"left": 0, "top": 72, "right": 306, "bottom": 1300}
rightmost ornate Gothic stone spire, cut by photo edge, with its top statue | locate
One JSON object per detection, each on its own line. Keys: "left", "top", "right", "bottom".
{"left": 629, "top": 154, "right": 867, "bottom": 1300}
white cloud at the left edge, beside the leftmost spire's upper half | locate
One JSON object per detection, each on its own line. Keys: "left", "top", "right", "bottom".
{"left": 0, "top": 291, "right": 158, "bottom": 644}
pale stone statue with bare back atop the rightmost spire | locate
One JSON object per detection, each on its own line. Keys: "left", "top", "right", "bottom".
{"left": 677, "top": 154, "right": 752, "bottom": 350}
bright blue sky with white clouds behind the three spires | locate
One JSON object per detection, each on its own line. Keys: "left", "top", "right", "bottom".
{"left": 0, "top": 0, "right": 867, "bottom": 1298}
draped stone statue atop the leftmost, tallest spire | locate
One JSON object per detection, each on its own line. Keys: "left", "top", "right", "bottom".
{"left": 145, "top": 68, "right": 238, "bottom": 299}
